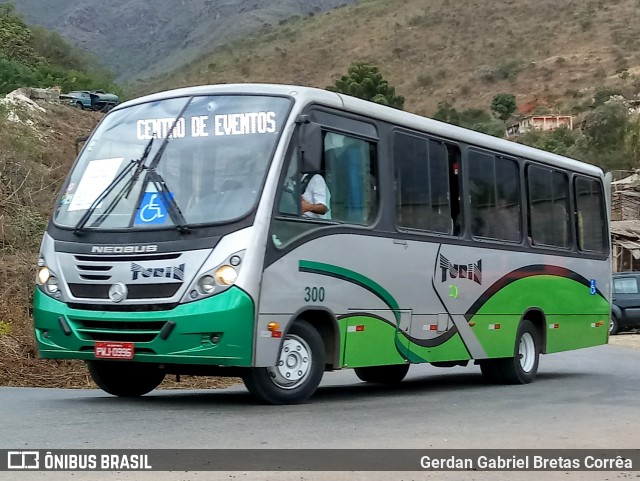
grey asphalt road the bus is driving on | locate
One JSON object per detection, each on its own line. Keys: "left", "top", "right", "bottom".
{"left": 0, "top": 345, "right": 640, "bottom": 481}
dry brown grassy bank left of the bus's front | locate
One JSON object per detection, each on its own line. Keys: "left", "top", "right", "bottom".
{"left": 0, "top": 99, "right": 101, "bottom": 386}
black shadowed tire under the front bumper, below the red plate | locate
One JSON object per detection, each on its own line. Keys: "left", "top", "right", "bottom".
{"left": 87, "top": 361, "right": 165, "bottom": 397}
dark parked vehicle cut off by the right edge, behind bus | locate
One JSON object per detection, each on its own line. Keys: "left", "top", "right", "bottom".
{"left": 609, "top": 272, "right": 640, "bottom": 334}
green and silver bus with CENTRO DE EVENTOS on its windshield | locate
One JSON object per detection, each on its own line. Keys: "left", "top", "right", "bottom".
{"left": 34, "top": 84, "right": 611, "bottom": 404}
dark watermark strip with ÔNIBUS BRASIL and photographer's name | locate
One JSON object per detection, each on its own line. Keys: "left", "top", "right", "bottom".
{"left": 0, "top": 449, "right": 640, "bottom": 471}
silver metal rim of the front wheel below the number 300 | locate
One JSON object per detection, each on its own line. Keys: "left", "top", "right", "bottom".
{"left": 267, "top": 335, "right": 312, "bottom": 389}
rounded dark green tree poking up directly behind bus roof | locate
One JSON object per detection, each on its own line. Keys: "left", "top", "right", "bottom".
{"left": 327, "top": 61, "right": 404, "bottom": 109}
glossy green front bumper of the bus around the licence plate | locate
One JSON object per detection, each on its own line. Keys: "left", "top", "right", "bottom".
{"left": 34, "top": 287, "right": 255, "bottom": 367}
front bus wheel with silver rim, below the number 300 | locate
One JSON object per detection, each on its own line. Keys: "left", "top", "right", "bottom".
{"left": 242, "top": 320, "right": 325, "bottom": 404}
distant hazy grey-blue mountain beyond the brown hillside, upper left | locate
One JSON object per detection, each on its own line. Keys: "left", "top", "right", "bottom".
{"left": 0, "top": 0, "right": 357, "bottom": 81}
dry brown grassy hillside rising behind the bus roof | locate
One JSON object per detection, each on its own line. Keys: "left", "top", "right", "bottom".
{"left": 148, "top": 0, "right": 640, "bottom": 115}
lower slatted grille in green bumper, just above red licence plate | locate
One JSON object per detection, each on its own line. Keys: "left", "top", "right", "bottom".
{"left": 73, "top": 319, "right": 167, "bottom": 342}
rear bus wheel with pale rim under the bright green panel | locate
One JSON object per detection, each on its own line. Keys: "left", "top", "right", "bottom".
{"left": 497, "top": 319, "right": 540, "bottom": 384}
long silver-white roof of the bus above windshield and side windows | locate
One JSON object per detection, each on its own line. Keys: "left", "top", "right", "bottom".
{"left": 119, "top": 83, "right": 604, "bottom": 177}
